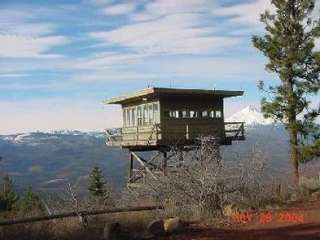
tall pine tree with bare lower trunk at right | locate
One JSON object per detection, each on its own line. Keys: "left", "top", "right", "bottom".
{"left": 252, "top": 0, "right": 320, "bottom": 183}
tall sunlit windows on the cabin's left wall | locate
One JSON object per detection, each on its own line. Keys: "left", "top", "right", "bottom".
{"left": 123, "top": 103, "right": 159, "bottom": 127}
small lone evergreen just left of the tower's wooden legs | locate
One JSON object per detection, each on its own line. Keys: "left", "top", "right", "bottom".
{"left": 88, "top": 166, "right": 109, "bottom": 198}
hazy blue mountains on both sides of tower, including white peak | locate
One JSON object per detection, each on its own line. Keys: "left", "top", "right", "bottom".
{"left": 0, "top": 106, "right": 314, "bottom": 195}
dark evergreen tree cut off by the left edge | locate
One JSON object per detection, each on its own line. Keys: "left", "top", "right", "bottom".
{"left": 0, "top": 175, "right": 18, "bottom": 211}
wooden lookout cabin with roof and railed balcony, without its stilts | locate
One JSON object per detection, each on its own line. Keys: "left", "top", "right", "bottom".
{"left": 105, "top": 88, "right": 244, "bottom": 150}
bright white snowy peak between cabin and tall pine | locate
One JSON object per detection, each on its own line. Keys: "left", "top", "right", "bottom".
{"left": 226, "top": 105, "right": 274, "bottom": 126}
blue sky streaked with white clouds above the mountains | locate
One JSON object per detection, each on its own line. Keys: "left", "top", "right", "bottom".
{"left": 0, "top": 0, "right": 320, "bottom": 134}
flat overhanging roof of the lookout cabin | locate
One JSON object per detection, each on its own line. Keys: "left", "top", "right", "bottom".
{"left": 104, "top": 87, "right": 243, "bottom": 104}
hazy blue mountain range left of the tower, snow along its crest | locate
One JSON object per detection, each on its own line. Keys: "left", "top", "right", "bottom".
{"left": 0, "top": 130, "right": 128, "bottom": 191}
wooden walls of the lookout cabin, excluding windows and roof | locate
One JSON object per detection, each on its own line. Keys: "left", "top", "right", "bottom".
{"left": 122, "top": 96, "right": 225, "bottom": 146}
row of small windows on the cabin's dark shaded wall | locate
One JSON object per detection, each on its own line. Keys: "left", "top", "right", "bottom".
{"left": 165, "top": 110, "right": 222, "bottom": 118}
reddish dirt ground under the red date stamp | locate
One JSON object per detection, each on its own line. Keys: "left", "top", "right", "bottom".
{"left": 165, "top": 201, "right": 320, "bottom": 240}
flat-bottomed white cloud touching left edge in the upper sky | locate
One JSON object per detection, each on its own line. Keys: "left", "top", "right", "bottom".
{"left": 0, "top": 35, "right": 67, "bottom": 58}
